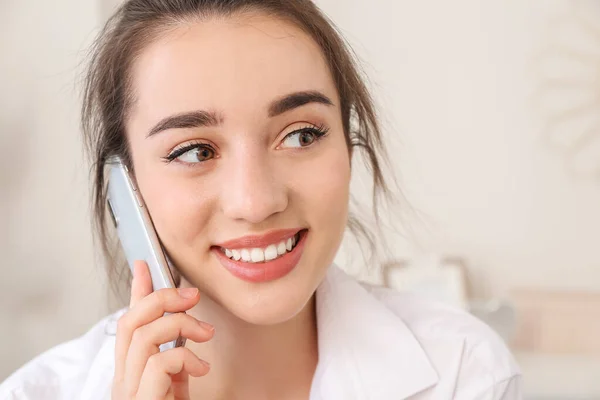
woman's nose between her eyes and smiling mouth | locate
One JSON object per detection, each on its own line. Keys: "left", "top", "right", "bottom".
{"left": 220, "top": 153, "right": 288, "bottom": 224}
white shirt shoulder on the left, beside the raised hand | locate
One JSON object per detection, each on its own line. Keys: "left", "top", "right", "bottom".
{"left": 0, "top": 310, "right": 123, "bottom": 400}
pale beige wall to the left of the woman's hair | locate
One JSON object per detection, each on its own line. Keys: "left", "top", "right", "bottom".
{"left": 0, "top": 0, "right": 107, "bottom": 381}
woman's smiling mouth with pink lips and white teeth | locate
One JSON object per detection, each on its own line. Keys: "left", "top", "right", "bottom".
{"left": 211, "top": 229, "right": 308, "bottom": 283}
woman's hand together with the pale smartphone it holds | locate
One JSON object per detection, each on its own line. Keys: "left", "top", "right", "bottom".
{"left": 108, "top": 158, "right": 214, "bottom": 400}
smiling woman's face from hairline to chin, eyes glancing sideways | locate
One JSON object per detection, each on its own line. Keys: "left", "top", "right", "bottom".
{"left": 127, "top": 16, "right": 350, "bottom": 324}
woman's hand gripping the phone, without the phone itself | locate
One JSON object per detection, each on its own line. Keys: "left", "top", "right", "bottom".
{"left": 112, "top": 261, "right": 214, "bottom": 400}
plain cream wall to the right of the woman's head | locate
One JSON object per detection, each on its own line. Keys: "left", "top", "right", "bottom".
{"left": 324, "top": 0, "right": 600, "bottom": 295}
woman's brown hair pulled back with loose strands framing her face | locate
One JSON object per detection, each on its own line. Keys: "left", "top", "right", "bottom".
{"left": 81, "top": 0, "right": 396, "bottom": 300}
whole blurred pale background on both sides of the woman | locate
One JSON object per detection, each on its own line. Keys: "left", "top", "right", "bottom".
{"left": 0, "top": 0, "right": 600, "bottom": 399}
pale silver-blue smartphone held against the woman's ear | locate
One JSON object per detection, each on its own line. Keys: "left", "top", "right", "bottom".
{"left": 107, "top": 157, "right": 185, "bottom": 351}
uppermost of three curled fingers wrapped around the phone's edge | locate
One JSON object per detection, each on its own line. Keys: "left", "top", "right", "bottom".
{"left": 114, "top": 288, "right": 200, "bottom": 390}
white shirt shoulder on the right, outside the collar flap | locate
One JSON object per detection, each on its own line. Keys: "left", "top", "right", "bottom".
{"left": 363, "top": 285, "right": 521, "bottom": 399}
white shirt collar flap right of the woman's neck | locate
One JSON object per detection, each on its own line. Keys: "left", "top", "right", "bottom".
{"left": 311, "top": 265, "right": 438, "bottom": 400}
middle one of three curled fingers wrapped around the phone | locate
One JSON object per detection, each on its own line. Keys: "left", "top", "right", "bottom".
{"left": 125, "top": 313, "right": 214, "bottom": 393}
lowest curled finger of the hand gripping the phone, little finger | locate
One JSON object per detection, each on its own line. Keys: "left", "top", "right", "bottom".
{"left": 136, "top": 347, "right": 210, "bottom": 399}
